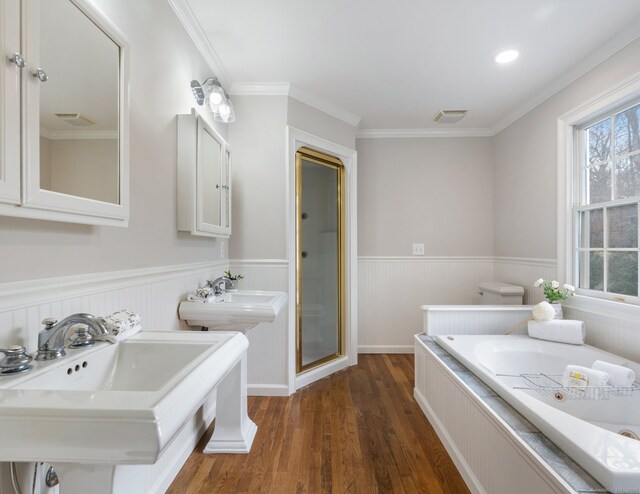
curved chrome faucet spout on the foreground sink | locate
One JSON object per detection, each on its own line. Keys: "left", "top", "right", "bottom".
{"left": 36, "top": 314, "right": 109, "bottom": 360}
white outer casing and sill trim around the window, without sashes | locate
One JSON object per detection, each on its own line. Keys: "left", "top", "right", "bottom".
{"left": 557, "top": 72, "right": 640, "bottom": 322}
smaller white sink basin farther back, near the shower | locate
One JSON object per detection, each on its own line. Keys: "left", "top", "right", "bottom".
{"left": 178, "top": 290, "right": 287, "bottom": 332}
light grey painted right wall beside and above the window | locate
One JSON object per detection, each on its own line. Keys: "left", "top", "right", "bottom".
{"left": 493, "top": 39, "right": 640, "bottom": 259}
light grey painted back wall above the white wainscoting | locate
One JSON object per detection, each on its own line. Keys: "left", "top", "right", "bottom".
{"left": 357, "top": 137, "right": 493, "bottom": 256}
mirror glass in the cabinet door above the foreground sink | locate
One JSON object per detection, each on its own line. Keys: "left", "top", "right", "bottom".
{"left": 39, "top": 0, "right": 120, "bottom": 204}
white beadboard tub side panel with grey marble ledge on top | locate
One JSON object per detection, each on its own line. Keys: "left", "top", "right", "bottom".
{"left": 414, "top": 335, "right": 606, "bottom": 494}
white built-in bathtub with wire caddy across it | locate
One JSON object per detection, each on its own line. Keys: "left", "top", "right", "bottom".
{"left": 435, "top": 335, "right": 640, "bottom": 493}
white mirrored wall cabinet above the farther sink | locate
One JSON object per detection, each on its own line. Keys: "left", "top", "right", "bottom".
{"left": 178, "top": 110, "right": 231, "bottom": 238}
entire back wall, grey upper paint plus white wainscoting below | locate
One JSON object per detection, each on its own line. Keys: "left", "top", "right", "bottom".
{"left": 357, "top": 137, "right": 493, "bottom": 353}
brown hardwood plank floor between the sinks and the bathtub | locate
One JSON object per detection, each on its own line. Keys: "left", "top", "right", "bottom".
{"left": 167, "top": 355, "right": 469, "bottom": 494}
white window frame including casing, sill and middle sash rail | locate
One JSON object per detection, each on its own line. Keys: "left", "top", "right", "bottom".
{"left": 557, "top": 73, "right": 640, "bottom": 321}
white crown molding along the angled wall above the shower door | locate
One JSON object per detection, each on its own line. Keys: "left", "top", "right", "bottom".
{"left": 229, "top": 82, "right": 362, "bottom": 127}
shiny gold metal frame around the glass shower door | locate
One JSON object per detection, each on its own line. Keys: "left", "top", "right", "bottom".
{"left": 296, "top": 147, "right": 345, "bottom": 374}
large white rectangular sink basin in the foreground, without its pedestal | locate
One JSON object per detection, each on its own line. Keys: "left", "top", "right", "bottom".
{"left": 0, "top": 331, "right": 248, "bottom": 465}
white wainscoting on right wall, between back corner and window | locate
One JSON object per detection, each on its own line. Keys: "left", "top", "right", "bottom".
{"left": 493, "top": 257, "right": 556, "bottom": 305}
